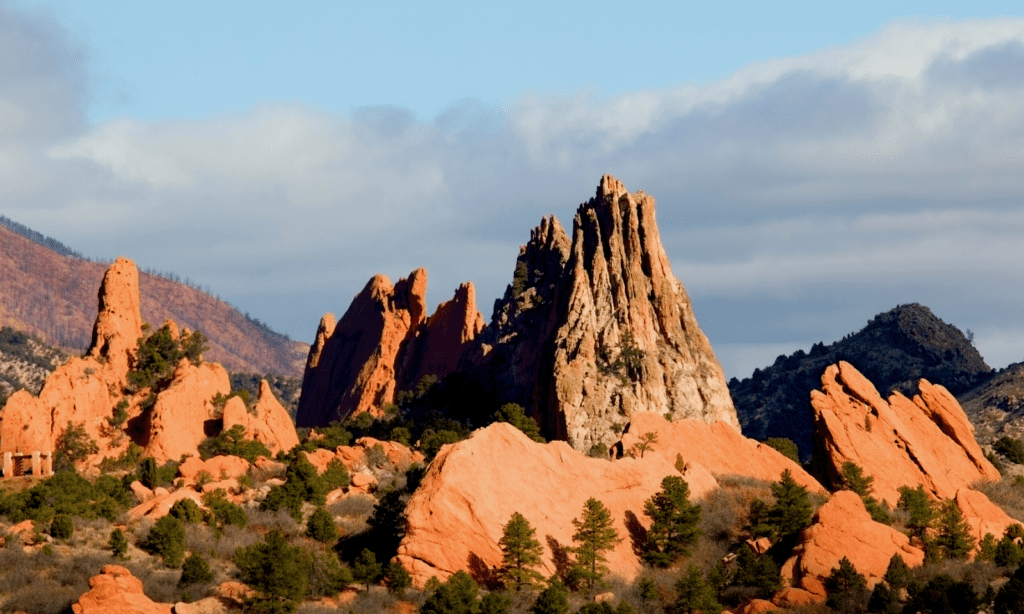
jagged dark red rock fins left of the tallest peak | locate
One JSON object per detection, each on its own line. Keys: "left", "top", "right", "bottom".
{"left": 296, "top": 268, "right": 482, "bottom": 427}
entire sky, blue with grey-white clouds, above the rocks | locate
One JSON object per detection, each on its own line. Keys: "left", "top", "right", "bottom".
{"left": 0, "top": 0, "right": 1024, "bottom": 377}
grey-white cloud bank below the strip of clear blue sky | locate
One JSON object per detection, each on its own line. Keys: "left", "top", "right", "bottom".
{"left": 6, "top": 13, "right": 1024, "bottom": 368}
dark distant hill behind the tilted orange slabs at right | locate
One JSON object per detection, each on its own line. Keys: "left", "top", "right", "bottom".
{"left": 729, "top": 303, "right": 991, "bottom": 457}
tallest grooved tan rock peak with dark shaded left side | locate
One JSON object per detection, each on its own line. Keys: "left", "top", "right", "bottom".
{"left": 474, "top": 175, "right": 739, "bottom": 450}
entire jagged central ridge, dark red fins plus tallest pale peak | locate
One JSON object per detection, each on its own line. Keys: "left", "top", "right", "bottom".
{"left": 296, "top": 175, "right": 738, "bottom": 451}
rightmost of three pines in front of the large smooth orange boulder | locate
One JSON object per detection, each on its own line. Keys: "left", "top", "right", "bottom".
{"left": 643, "top": 476, "right": 700, "bottom": 567}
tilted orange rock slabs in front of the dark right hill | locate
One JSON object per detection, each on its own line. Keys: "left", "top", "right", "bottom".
{"left": 811, "top": 362, "right": 999, "bottom": 506}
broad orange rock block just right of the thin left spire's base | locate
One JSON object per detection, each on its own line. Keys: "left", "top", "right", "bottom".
{"left": 143, "top": 358, "right": 231, "bottom": 463}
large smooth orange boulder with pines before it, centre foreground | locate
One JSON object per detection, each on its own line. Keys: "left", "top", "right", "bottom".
{"left": 397, "top": 423, "right": 717, "bottom": 586}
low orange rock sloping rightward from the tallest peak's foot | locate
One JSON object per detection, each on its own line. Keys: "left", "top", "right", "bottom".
{"left": 620, "top": 411, "right": 824, "bottom": 492}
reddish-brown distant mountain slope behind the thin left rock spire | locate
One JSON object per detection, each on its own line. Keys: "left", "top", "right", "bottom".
{"left": 0, "top": 224, "right": 309, "bottom": 378}
